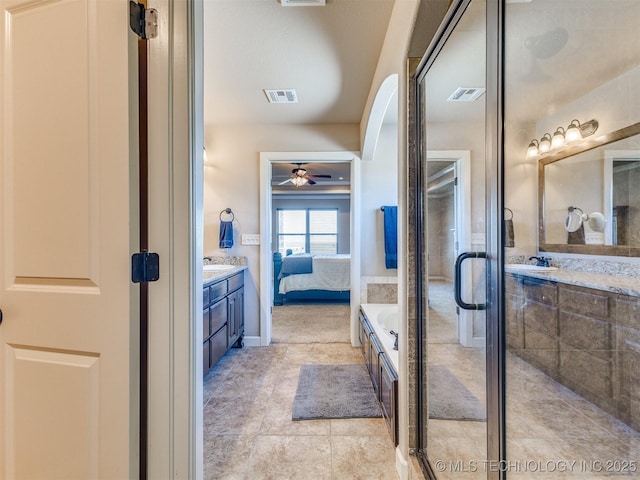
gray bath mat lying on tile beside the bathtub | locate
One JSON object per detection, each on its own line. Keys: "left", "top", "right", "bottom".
{"left": 292, "top": 364, "right": 382, "bottom": 420}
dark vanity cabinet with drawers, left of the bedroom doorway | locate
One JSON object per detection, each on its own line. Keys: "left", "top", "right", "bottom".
{"left": 202, "top": 271, "right": 244, "bottom": 375}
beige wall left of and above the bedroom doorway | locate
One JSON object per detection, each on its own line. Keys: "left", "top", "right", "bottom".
{"left": 204, "top": 125, "right": 360, "bottom": 336}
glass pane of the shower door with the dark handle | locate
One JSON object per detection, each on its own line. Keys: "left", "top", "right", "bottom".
{"left": 418, "top": 0, "right": 487, "bottom": 479}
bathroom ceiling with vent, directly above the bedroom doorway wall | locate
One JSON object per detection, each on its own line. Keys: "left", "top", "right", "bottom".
{"left": 204, "top": 0, "right": 394, "bottom": 127}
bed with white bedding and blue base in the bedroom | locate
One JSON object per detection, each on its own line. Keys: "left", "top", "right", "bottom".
{"left": 273, "top": 252, "right": 351, "bottom": 305}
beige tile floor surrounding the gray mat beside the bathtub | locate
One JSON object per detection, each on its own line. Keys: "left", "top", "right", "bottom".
{"left": 204, "top": 324, "right": 398, "bottom": 480}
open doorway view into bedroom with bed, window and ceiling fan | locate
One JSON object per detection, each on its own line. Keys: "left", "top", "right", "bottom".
{"left": 271, "top": 162, "right": 351, "bottom": 343}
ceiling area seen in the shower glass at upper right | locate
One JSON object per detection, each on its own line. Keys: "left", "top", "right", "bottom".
{"left": 420, "top": 0, "right": 640, "bottom": 122}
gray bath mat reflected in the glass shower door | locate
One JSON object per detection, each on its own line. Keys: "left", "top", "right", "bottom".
{"left": 429, "top": 365, "right": 486, "bottom": 422}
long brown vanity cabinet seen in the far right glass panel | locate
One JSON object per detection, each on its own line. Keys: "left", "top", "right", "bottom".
{"left": 505, "top": 275, "right": 640, "bottom": 429}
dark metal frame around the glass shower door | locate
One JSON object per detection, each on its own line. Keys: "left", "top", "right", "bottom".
{"left": 409, "top": 0, "right": 506, "bottom": 480}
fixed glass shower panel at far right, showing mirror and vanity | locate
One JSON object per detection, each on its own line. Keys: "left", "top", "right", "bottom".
{"left": 504, "top": 0, "right": 640, "bottom": 479}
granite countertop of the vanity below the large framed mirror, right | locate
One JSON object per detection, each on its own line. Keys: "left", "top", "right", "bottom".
{"left": 508, "top": 268, "right": 640, "bottom": 297}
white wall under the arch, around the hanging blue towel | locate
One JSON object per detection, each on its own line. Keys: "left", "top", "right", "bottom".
{"left": 360, "top": 122, "right": 402, "bottom": 277}
